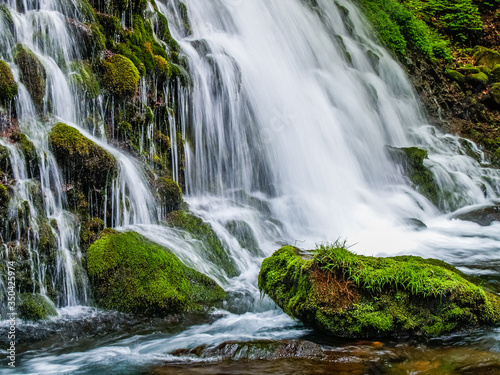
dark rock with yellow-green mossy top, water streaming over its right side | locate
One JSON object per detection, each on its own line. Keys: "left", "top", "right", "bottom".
{"left": 49, "top": 122, "right": 117, "bottom": 196}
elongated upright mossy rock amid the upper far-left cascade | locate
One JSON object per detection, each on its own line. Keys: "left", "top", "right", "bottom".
{"left": 12, "top": 44, "right": 47, "bottom": 110}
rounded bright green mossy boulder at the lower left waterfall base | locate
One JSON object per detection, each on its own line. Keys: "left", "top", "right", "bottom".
{"left": 87, "top": 232, "right": 225, "bottom": 315}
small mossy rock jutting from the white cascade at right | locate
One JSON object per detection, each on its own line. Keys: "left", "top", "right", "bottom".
{"left": 386, "top": 147, "right": 439, "bottom": 206}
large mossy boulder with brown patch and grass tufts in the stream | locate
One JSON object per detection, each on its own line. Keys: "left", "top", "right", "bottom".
{"left": 259, "top": 243, "right": 500, "bottom": 337}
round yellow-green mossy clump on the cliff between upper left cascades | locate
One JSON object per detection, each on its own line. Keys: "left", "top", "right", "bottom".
{"left": 102, "top": 55, "right": 140, "bottom": 97}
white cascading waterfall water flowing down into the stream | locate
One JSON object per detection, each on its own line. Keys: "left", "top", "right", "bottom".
{"left": 0, "top": 0, "right": 500, "bottom": 374}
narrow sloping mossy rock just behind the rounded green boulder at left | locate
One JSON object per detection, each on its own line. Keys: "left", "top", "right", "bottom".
{"left": 168, "top": 211, "right": 238, "bottom": 277}
